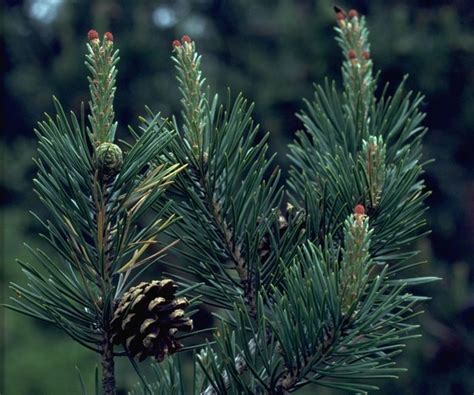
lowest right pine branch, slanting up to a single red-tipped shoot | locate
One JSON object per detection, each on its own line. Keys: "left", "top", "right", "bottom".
{"left": 196, "top": 214, "right": 422, "bottom": 394}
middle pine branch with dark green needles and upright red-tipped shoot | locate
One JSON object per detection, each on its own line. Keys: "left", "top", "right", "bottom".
{"left": 156, "top": 36, "right": 288, "bottom": 309}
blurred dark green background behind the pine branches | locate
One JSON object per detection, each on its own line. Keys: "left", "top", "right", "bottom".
{"left": 0, "top": 0, "right": 474, "bottom": 395}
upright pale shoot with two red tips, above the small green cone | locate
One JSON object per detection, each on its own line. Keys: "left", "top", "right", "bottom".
{"left": 85, "top": 30, "right": 119, "bottom": 145}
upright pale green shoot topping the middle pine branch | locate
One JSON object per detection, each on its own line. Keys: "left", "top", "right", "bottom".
{"left": 172, "top": 36, "right": 207, "bottom": 154}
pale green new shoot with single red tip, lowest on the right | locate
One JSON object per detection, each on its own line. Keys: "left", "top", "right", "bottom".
{"left": 339, "top": 204, "right": 372, "bottom": 315}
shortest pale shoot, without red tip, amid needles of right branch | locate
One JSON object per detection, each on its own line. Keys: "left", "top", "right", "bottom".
{"left": 362, "top": 136, "right": 386, "bottom": 208}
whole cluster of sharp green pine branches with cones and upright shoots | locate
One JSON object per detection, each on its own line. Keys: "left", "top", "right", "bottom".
{"left": 6, "top": 8, "right": 435, "bottom": 395}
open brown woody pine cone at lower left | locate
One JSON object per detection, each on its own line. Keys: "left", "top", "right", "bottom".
{"left": 111, "top": 279, "right": 193, "bottom": 362}
